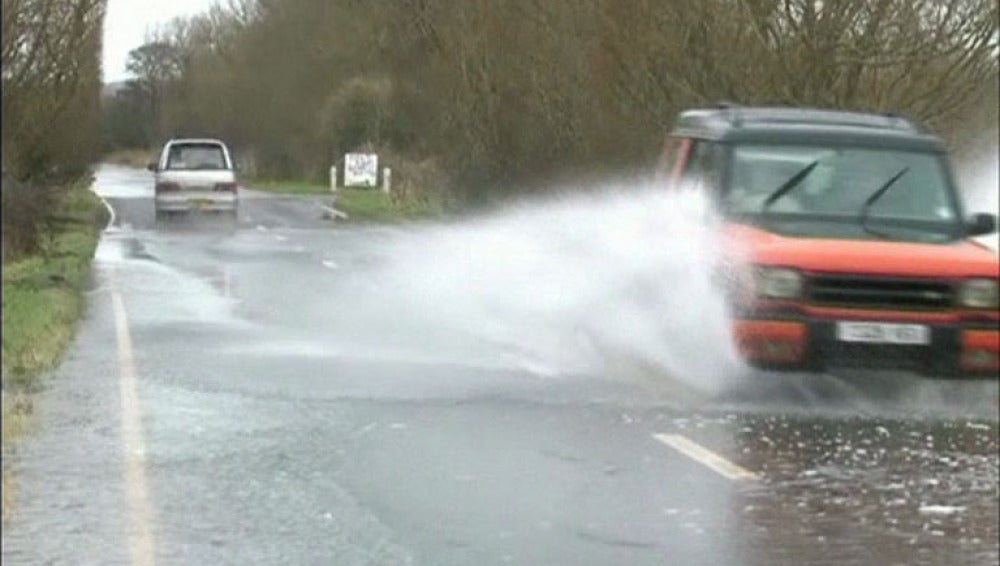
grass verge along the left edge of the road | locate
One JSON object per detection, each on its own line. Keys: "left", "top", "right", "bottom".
{"left": 2, "top": 179, "right": 107, "bottom": 520}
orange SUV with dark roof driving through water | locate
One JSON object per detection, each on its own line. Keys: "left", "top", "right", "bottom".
{"left": 661, "top": 105, "right": 1000, "bottom": 376}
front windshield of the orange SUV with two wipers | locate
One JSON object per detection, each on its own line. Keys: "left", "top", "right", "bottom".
{"left": 723, "top": 145, "right": 960, "bottom": 241}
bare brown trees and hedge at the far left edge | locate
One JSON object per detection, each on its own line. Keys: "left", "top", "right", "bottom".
{"left": 2, "top": 0, "right": 105, "bottom": 258}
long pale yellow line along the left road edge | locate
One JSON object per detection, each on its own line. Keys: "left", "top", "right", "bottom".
{"left": 111, "top": 292, "right": 156, "bottom": 566}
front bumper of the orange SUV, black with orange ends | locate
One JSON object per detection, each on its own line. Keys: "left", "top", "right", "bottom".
{"left": 733, "top": 319, "right": 1000, "bottom": 377}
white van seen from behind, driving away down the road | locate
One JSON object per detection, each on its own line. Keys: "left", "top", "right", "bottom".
{"left": 148, "top": 139, "right": 238, "bottom": 216}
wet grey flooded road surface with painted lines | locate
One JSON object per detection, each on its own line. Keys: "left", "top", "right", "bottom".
{"left": 3, "top": 167, "right": 1000, "bottom": 565}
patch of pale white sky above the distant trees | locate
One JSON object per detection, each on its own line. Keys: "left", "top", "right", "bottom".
{"left": 104, "top": 0, "right": 214, "bottom": 83}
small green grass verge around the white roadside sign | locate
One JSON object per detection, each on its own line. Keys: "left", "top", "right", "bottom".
{"left": 246, "top": 180, "right": 443, "bottom": 223}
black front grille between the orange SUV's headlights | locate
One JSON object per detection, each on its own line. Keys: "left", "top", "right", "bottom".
{"left": 807, "top": 275, "right": 955, "bottom": 310}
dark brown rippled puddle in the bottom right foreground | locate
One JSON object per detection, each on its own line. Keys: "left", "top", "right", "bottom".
{"left": 732, "top": 417, "right": 1000, "bottom": 564}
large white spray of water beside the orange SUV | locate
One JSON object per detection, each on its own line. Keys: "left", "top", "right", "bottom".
{"left": 332, "top": 187, "right": 739, "bottom": 398}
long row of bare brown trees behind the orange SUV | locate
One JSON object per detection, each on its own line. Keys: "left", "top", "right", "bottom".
{"left": 97, "top": 0, "right": 998, "bottom": 203}
